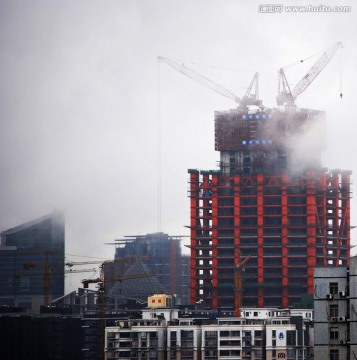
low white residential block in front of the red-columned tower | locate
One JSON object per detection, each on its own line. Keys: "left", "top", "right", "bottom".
{"left": 105, "top": 308, "right": 313, "bottom": 360}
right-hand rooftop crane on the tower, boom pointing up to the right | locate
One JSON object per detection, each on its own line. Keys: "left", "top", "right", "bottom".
{"left": 276, "top": 41, "right": 343, "bottom": 107}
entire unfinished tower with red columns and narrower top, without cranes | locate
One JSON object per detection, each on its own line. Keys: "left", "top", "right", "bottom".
{"left": 188, "top": 106, "right": 351, "bottom": 309}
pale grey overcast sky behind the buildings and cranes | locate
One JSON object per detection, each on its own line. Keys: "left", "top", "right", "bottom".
{"left": 0, "top": 0, "right": 357, "bottom": 292}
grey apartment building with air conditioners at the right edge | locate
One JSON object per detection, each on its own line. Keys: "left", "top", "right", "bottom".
{"left": 314, "top": 257, "right": 357, "bottom": 360}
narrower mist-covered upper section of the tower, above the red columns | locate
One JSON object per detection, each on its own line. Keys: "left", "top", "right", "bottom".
{"left": 215, "top": 107, "right": 325, "bottom": 175}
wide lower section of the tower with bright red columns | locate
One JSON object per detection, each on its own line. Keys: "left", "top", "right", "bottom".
{"left": 190, "top": 170, "right": 350, "bottom": 309}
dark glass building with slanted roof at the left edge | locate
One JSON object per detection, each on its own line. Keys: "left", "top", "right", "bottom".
{"left": 0, "top": 213, "right": 65, "bottom": 311}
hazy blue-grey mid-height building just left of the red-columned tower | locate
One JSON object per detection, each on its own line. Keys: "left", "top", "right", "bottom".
{"left": 104, "top": 232, "right": 190, "bottom": 304}
